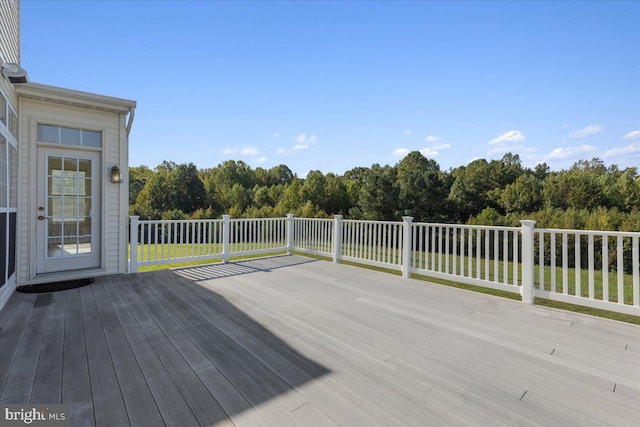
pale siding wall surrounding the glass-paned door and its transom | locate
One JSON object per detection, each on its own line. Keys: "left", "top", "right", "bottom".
{"left": 17, "top": 97, "right": 127, "bottom": 285}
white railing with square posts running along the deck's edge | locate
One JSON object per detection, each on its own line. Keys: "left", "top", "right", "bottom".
{"left": 129, "top": 215, "right": 640, "bottom": 315}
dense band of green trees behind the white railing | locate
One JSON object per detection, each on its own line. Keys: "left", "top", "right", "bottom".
{"left": 129, "top": 151, "right": 640, "bottom": 231}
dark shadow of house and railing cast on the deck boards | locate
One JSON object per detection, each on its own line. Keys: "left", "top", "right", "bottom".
{"left": 0, "top": 257, "right": 329, "bottom": 426}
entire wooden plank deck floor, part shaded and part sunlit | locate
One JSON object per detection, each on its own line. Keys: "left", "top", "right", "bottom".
{"left": 0, "top": 256, "right": 640, "bottom": 426}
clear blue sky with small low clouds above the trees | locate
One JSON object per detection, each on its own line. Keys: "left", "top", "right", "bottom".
{"left": 21, "top": 0, "right": 640, "bottom": 176}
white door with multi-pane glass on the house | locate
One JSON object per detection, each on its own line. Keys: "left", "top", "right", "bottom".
{"left": 35, "top": 147, "right": 101, "bottom": 274}
